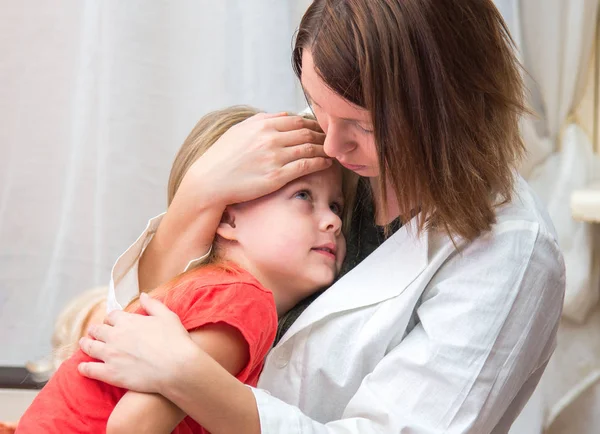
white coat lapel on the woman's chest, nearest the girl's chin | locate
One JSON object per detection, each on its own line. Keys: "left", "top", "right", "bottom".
{"left": 278, "top": 219, "right": 428, "bottom": 346}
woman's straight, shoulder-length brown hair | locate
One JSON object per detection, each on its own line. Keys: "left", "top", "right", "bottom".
{"left": 293, "top": 0, "right": 525, "bottom": 240}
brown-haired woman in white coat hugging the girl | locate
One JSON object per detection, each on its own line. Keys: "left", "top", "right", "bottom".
{"left": 80, "top": 0, "right": 565, "bottom": 433}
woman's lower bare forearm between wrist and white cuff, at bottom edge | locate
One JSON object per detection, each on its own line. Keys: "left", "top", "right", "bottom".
{"left": 161, "top": 348, "right": 260, "bottom": 434}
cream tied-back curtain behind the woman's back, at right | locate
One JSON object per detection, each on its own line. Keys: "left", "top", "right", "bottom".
{"left": 496, "top": 0, "right": 600, "bottom": 434}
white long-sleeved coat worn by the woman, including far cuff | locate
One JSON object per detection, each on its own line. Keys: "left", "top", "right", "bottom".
{"left": 111, "top": 178, "right": 565, "bottom": 434}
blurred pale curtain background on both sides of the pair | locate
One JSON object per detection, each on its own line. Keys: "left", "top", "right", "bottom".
{"left": 0, "top": 0, "right": 600, "bottom": 434}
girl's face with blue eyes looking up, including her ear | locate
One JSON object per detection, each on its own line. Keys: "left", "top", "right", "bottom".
{"left": 217, "top": 164, "right": 346, "bottom": 306}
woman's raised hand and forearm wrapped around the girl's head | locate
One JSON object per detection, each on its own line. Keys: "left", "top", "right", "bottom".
{"left": 139, "top": 113, "right": 331, "bottom": 291}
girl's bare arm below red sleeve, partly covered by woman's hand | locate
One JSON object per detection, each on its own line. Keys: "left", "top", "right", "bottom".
{"left": 106, "top": 323, "right": 249, "bottom": 434}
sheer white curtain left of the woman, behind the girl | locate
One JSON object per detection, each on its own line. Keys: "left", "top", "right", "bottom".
{"left": 0, "top": 0, "right": 310, "bottom": 365}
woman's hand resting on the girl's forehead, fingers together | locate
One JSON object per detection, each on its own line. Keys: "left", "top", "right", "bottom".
{"left": 174, "top": 113, "right": 331, "bottom": 210}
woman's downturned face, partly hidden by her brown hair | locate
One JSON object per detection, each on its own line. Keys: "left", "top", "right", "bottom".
{"left": 301, "top": 49, "right": 379, "bottom": 177}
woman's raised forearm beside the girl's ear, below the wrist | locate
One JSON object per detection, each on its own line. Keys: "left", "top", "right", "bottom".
{"left": 138, "top": 198, "right": 225, "bottom": 292}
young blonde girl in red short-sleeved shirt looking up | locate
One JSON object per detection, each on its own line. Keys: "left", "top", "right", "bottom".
{"left": 17, "top": 107, "right": 346, "bottom": 434}
